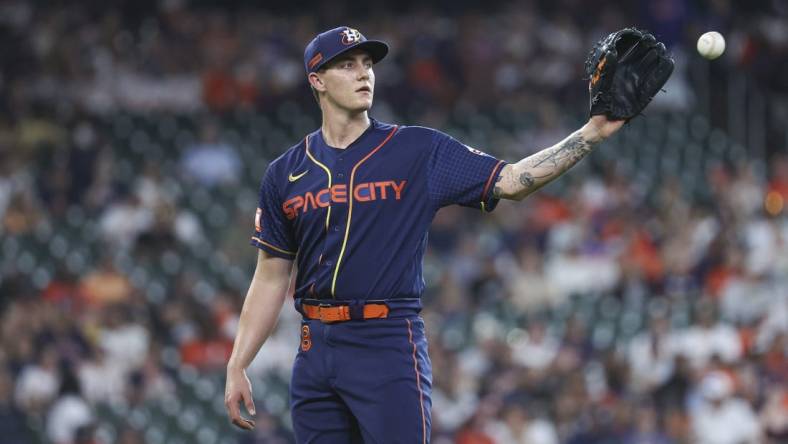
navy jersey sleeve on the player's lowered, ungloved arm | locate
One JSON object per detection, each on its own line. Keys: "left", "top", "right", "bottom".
{"left": 250, "top": 166, "right": 297, "bottom": 259}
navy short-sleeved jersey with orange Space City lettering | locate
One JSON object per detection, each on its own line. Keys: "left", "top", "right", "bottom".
{"left": 251, "top": 119, "right": 504, "bottom": 306}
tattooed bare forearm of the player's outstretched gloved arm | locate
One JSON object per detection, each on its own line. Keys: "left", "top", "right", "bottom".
{"left": 493, "top": 131, "right": 595, "bottom": 200}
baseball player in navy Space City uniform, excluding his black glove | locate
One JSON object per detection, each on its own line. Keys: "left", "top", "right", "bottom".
{"left": 225, "top": 27, "right": 668, "bottom": 443}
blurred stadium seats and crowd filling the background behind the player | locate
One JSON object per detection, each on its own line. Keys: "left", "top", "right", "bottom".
{"left": 0, "top": 0, "right": 788, "bottom": 444}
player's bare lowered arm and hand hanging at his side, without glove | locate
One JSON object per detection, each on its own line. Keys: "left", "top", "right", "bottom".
{"left": 224, "top": 250, "right": 293, "bottom": 430}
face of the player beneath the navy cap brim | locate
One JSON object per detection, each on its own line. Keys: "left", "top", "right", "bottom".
{"left": 320, "top": 49, "right": 375, "bottom": 112}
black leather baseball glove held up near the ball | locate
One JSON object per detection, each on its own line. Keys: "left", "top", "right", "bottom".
{"left": 585, "top": 28, "right": 674, "bottom": 121}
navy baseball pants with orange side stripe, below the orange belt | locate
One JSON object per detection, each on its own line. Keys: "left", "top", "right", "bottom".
{"left": 290, "top": 314, "right": 432, "bottom": 444}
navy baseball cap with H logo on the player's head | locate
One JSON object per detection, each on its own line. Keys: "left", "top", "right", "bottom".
{"left": 304, "top": 26, "right": 389, "bottom": 74}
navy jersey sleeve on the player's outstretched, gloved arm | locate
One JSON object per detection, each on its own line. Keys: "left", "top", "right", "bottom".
{"left": 427, "top": 131, "right": 506, "bottom": 212}
